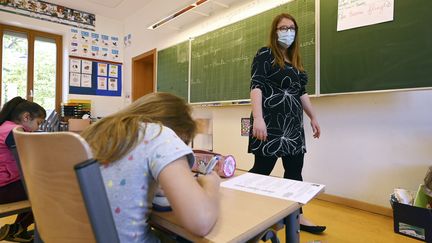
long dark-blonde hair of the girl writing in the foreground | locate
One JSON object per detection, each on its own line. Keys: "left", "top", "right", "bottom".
{"left": 81, "top": 93, "right": 196, "bottom": 164}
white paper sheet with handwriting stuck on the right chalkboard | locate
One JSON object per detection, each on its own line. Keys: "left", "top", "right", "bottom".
{"left": 337, "top": 0, "right": 394, "bottom": 31}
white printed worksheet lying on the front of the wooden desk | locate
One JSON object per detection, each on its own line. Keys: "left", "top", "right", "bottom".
{"left": 221, "top": 173, "right": 325, "bottom": 204}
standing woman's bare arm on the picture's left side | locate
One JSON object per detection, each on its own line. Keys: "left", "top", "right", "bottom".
{"left": 250, "top": 88, "right": 267, "bottom": 140}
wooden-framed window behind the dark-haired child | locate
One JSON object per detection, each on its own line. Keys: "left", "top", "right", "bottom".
{"left": 0, "top": 24, "right": 62, "bottom": 111}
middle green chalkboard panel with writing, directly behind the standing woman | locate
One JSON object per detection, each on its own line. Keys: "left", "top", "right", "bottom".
{"left": 190, "top": 0, "right": 315, "bottom": 103}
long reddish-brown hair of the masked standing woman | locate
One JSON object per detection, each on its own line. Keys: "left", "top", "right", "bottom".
{"left": 268, "top": 13, "right": 304, "bottom": 72}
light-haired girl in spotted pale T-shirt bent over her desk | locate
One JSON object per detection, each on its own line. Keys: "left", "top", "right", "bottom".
{"left": 81, "top": 93, "right": 220, "bottom": 242}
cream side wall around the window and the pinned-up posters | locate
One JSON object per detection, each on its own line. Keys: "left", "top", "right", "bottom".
{"left": 0, "top": 11, "right": 125, "bottom": 116}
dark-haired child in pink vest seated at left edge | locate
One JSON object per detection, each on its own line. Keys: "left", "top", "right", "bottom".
{"left": 0, "top": 97, "right": 46, "bottom": 242}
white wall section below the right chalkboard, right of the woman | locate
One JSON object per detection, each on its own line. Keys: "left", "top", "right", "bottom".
{"left": 304, "top": 90, "right": 432, "bottom": 207}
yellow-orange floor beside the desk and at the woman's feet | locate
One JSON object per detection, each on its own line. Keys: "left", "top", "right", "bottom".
{"left": 0, "top": 199, "right": 421, "bottom": 243}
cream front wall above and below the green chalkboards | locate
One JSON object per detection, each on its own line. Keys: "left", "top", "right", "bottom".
{"left": 125, "top": 0, "right": 432, "bottom": 207}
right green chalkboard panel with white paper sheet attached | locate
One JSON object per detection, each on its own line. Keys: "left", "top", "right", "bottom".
{"left": 320, "top": 0, "right": 432, "bottom": 94}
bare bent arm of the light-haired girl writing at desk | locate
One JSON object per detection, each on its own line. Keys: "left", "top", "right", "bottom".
{"left": 158, "top": 156, "right": 220, "bottom": 236}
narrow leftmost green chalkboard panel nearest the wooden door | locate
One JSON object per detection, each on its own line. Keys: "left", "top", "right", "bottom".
{"left": 157, "top": 41, "right": 189, "bottom": 100}
